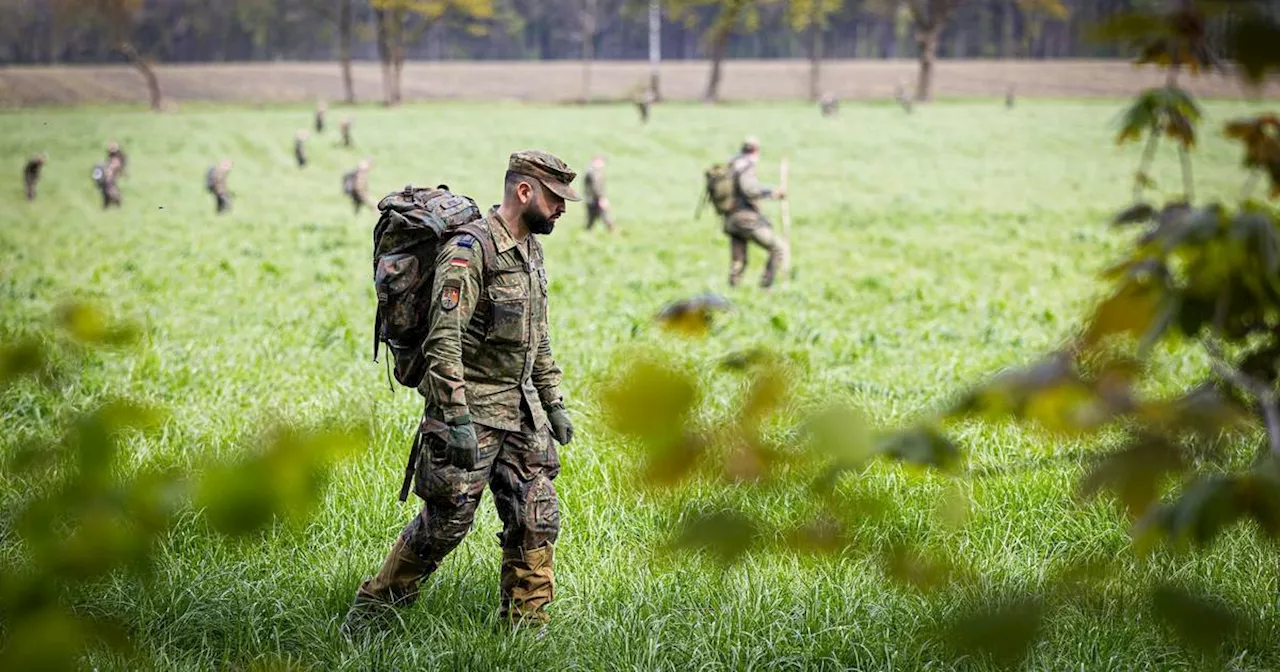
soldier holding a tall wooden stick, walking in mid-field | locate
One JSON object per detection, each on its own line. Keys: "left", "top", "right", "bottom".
{"left": 724, "top": 137, "right": 790, "bottom": 288}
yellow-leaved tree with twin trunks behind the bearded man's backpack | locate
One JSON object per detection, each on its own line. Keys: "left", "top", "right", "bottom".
{"left": 372, "top": 0, "right": 494, "bottom": 105}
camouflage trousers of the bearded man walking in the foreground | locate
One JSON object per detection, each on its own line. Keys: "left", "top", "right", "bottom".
{"left": 356, "top": 417, "right": 559, "bottom": 621}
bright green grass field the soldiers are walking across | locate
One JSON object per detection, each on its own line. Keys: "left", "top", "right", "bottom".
{"left": 0, "top": 100, "right": 1280, "bottom": 671}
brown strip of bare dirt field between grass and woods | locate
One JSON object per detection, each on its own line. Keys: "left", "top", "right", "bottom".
{"left": 0, "top": 60, "right": 1280, "bottom": 108}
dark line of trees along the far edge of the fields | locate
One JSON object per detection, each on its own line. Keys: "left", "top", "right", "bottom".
{"left": 0, "top": 0, "right": 1264, "bottom": 105}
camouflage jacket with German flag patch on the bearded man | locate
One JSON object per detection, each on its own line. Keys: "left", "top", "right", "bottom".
{"left": 419, "top": 207, "right": 562, "bottom": 431}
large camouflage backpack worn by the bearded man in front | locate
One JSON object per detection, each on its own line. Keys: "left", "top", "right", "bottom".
{"left": 374, "top": 186, "right": 497, "bottom": 388}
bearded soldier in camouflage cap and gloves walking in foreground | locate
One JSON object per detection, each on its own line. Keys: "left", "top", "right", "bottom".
{"left": 343, "top": 151, "right": 579, "bottom": 635}
